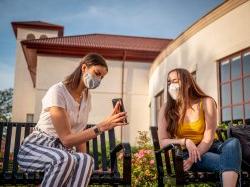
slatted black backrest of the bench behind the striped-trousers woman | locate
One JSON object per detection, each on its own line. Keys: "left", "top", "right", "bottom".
{"left": 0, "top": 122, "right": 117, "bottom": 174}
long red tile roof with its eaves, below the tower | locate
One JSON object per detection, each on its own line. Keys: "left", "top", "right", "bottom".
{"left": 21, "top": 34, "right": 172, "bottom": 87}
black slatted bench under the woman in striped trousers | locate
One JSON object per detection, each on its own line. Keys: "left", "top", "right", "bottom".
{"left": 0, "top": 122, "right": 131, "bottom": 186}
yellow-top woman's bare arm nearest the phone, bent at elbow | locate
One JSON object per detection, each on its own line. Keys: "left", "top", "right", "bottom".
{"left": 158, "top": 104, "right": 185, "bottom": 147}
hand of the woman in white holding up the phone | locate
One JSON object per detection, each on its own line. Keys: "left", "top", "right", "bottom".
{"left": 97, "top": 102, "right": 127, "bottom": 131}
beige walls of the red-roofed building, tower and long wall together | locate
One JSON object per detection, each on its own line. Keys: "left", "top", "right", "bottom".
{"left": 12, "top": 24, "right": 150, "bottom": 143}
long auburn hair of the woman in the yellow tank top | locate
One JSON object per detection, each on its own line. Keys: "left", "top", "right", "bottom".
{"left": 165, "top": 68, "right": 212, "bottom": 138}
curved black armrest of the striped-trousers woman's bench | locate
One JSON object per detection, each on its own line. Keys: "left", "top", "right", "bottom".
{"left": 110, "top": 143, "right": 131, "bottom": 183}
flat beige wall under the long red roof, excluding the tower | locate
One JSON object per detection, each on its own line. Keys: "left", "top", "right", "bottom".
{"left": 34, "top": 55, "right": 150, "bottom": 144}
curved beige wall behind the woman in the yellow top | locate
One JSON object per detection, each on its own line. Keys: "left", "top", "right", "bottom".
{"left": 149, "top": 1, "right": 250, "bottom": 125}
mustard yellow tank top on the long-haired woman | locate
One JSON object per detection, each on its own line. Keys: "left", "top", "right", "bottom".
{"left": 177, "top": 100, "right": 216, "bottom": 145}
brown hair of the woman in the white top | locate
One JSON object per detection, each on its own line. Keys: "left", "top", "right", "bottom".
{"left": 63, "top": 53, "right": 108, "bottom": 89}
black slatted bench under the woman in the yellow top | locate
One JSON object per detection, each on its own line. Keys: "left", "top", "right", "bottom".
{"left": 150, "top": 127, "right": 250, "bottom": 187}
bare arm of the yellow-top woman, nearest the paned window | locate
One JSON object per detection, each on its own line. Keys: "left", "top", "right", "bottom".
{"left": 198, "top": 98, "right": 217, "bottom": 155}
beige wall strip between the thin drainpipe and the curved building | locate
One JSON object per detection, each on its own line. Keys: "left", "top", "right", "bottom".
{"left": 123, "top": 62, "right": 150, "bottom": 144}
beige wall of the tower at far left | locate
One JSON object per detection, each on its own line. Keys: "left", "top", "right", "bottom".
{"left": 12, "top": 28, "right": 57, "bottom": 122}
